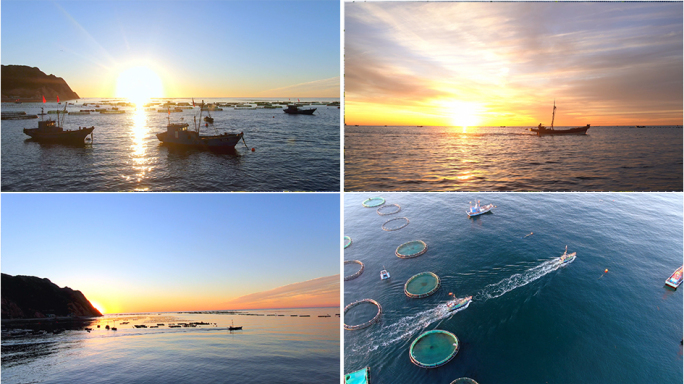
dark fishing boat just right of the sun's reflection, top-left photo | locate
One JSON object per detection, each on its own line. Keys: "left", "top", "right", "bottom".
{"left": 157, "top": 102, "right": 247, "bottom": 150}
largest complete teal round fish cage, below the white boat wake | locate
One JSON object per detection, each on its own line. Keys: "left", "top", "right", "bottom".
{"left": 409, "top": 329, "right": 459, "bottom": 368}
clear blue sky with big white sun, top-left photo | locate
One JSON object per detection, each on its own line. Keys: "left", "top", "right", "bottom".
{"left": 1, "top": 0, "right": 340, "bottom": 98}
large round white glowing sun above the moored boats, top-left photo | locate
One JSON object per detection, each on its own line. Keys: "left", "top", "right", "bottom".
{"left": 116, "top": 66, "right": 164, "bottom": 105}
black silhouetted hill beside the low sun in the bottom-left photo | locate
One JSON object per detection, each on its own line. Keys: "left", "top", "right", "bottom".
{"left": 2, "top": 273, "right": 102, "bottom": 319}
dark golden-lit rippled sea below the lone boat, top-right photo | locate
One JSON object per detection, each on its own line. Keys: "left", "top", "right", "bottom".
{"left": 344, "top": 125, "right": 683, "bottom": 192}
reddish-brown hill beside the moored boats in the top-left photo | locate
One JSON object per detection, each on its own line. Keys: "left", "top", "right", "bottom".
{"left": 1, "top": 65, "right": 79, "bottom": 101}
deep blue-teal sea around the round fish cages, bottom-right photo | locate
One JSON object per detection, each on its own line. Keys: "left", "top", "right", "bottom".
{"left": 344, "top": 193, "right": 684, "bottom": 384}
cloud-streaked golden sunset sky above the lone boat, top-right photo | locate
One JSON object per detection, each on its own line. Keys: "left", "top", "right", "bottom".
{"left": 344, "top": 2, "right": 683, "bottom": 126}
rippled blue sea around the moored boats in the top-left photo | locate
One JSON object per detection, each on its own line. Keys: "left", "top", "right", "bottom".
{"left": 2, "top": 98, "right": 340, "bottom": 192}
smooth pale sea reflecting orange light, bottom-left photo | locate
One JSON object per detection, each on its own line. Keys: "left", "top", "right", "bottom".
{"left": 2, "top": 308, "right": 340, "bottom": 384}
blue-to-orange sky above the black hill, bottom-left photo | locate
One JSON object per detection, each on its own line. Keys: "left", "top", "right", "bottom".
{"left": 1, "top": 193, "right": 341, "bottom": 313}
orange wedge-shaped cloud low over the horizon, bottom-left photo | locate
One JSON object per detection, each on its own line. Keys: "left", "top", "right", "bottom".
{"left": 221, "top": 275, "right": 340, "bottom": 309}
